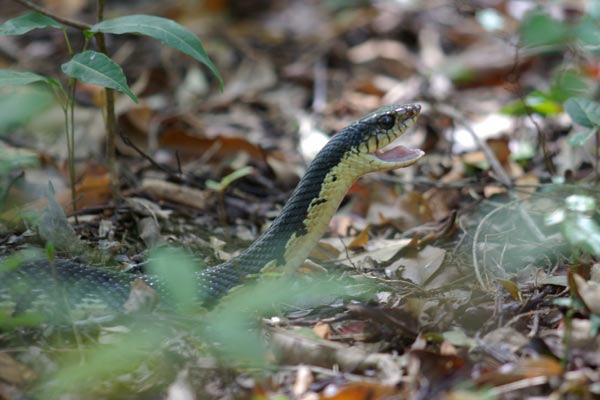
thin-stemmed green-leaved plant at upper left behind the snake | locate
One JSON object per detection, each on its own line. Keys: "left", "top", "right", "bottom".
{"left": 0, "top": 0, "right": 223, "bottom": 206}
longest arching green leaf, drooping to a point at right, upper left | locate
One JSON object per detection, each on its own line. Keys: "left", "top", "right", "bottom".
{"left": 90, "top": 14, "right": 223, "bottom": 89}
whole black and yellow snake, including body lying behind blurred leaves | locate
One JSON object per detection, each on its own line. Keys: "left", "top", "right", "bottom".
{"left": 0, "top": 104, "right": 425, "bottom": 317}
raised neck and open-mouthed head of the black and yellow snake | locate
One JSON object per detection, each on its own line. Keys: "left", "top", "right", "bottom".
{"left": 195, "top": 105, "right": 423, "bottom": 298}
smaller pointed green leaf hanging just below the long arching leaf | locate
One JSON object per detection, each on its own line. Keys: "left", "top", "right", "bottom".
{"left": 62, "top": 50, "right": 138, "bottom": 103}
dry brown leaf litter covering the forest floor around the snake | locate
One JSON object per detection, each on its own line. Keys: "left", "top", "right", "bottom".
{"left": 0, "top": 1, "right": 600, "bottom": 399}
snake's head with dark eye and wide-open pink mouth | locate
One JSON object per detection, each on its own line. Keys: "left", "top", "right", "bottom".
{"left": 346, "top": 104, "right": 425, "bottom": 172}
